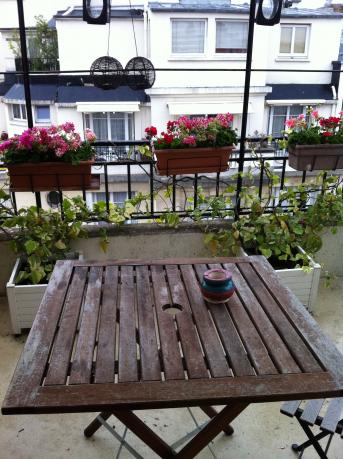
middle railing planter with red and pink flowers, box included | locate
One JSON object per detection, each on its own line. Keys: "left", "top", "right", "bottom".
{"left": 145, "top": 113, "right": 237, "bottom": 175}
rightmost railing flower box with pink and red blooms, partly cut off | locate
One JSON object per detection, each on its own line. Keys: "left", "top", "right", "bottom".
{"left": 286, "top": 107, "right": 343, "bottom": 171}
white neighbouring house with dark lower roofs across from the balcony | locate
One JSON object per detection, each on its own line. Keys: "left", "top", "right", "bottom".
{"left": 0, "top": 0, "right": 343, "bottom": 210}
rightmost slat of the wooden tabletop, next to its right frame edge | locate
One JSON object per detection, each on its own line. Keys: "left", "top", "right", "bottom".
{"left": 237, "top": 263, "right": 321, "bottom": 373}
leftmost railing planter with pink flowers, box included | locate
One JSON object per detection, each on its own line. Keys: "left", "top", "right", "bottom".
{"left": 0, "top": 123, "right": 99, "bottom": 191}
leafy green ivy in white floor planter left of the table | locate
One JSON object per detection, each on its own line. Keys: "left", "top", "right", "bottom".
{"left": 0, "top": 189, "right": 134, "bottom": 334}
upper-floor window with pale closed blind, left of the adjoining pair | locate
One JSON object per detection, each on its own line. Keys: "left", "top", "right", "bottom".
{"left": 171, "top": 19, "right": 206, "bottom": 54}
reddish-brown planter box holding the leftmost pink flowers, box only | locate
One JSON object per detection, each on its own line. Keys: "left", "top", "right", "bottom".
{"left": 7, "top": 161, "right": 93, "bottom": 191}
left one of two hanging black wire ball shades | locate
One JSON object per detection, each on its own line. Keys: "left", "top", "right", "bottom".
{"left": 90, "top": 56, "right": 124, "bottom": 89}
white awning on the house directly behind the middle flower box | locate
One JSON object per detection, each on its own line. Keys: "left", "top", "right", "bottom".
{"left": 168, "top": 101, "right": 253, "bottom": 115}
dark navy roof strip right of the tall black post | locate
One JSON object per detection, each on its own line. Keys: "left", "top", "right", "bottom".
{"left": 266, "top": 84, "right": 333, "bottom": 100}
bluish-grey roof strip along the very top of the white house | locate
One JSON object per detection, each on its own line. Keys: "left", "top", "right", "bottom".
{"left": 149, "top": 0, "right": 343, "bottom": 19}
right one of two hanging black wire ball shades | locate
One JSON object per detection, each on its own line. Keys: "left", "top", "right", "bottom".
{"left": 125, "top": 57, "right": 156, "bottom": 90}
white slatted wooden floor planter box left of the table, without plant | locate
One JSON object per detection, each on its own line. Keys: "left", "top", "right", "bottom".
{"left": 6, "top": 258, "right": 48, "bottom": 335}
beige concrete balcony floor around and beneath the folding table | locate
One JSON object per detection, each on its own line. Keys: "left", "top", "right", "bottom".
{"left": 0, "top": 278, "right": 343, "bottom": 459}
